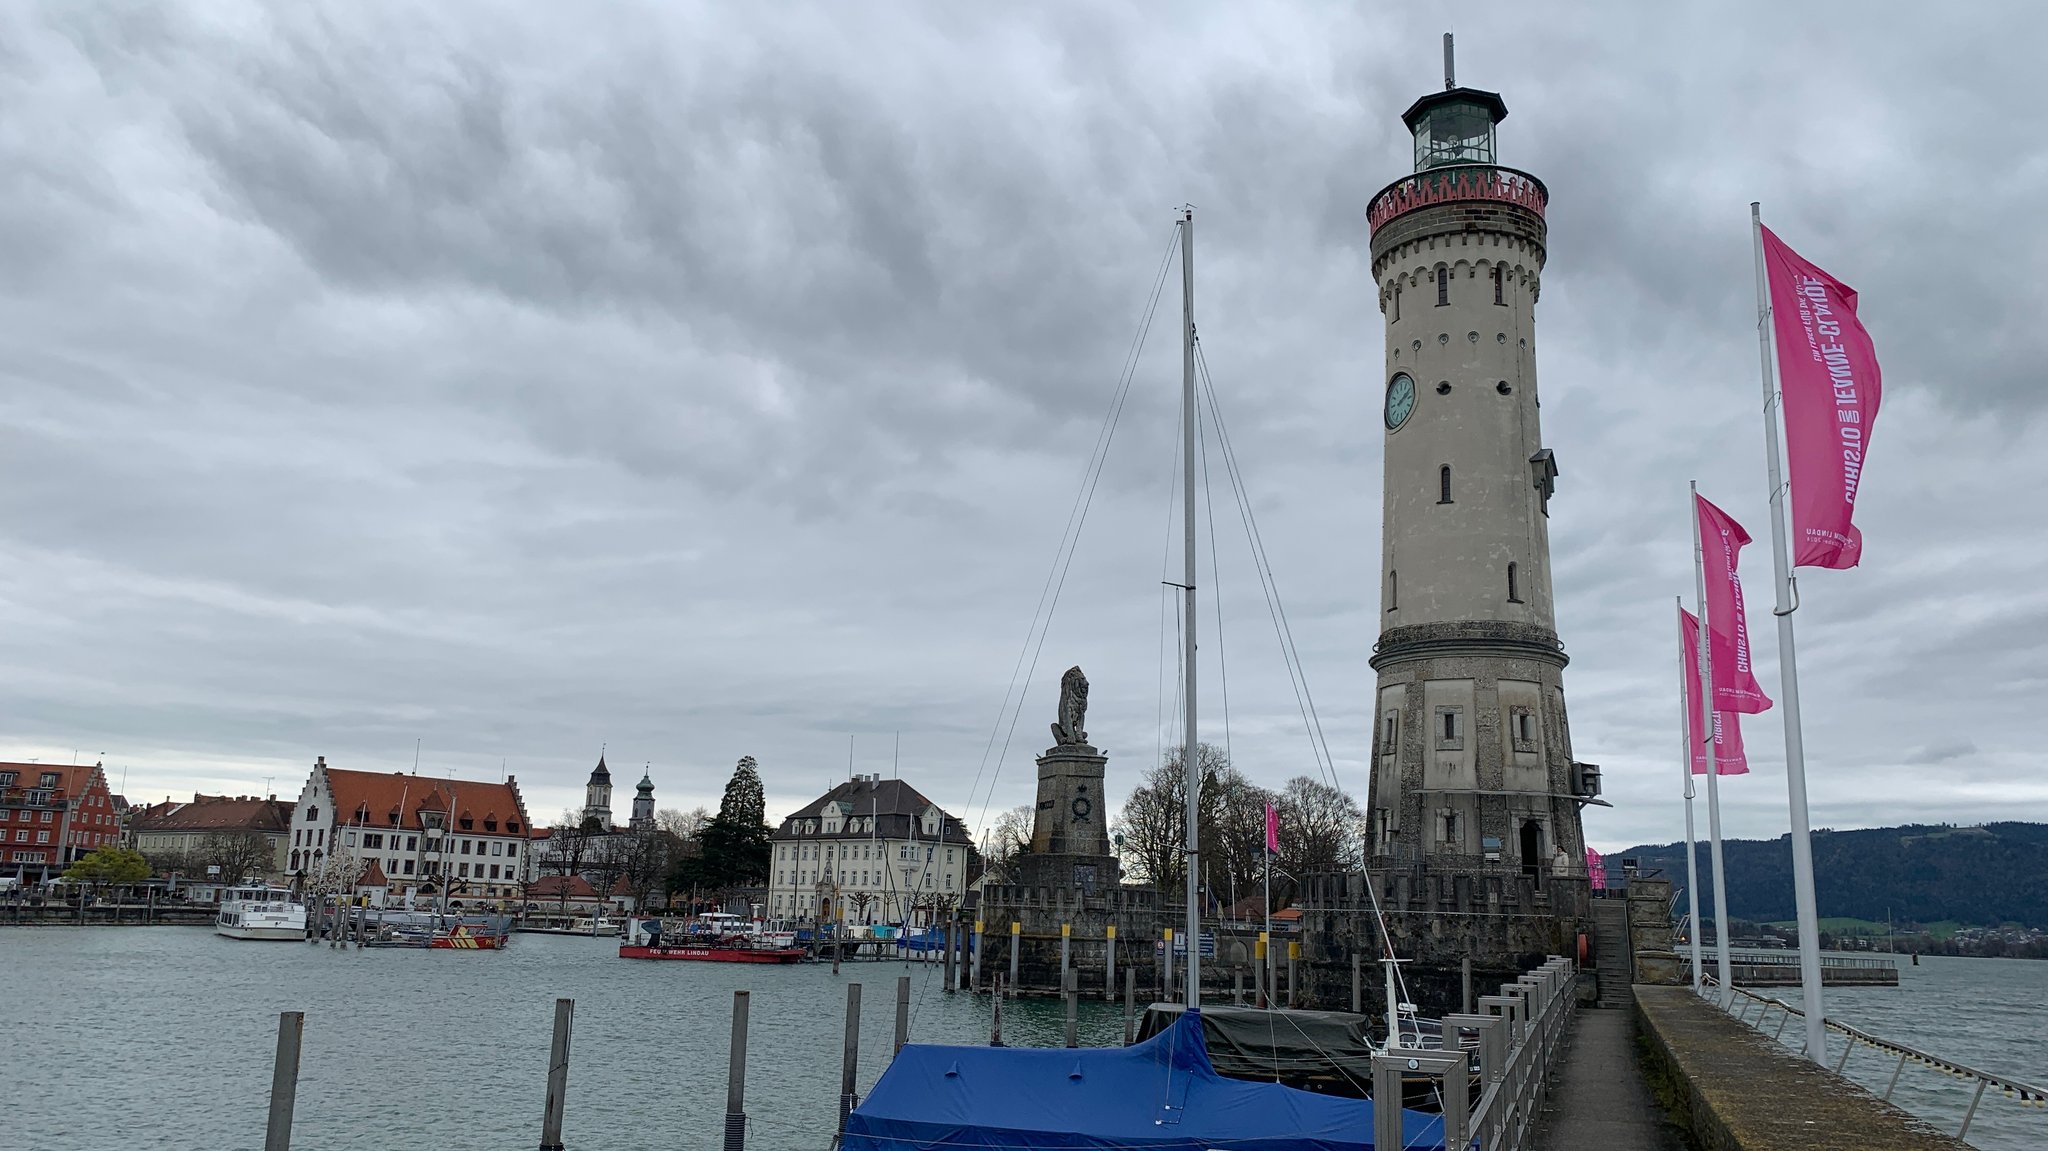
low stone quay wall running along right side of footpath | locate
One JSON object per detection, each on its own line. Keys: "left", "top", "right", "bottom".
{"left": 1634, "top": 985, "right": 1968, "bottom": 1151}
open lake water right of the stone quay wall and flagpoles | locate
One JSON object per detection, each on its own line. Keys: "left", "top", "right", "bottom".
{"left": 1767, "top": 956, "right": 2048, "bottom": 1151}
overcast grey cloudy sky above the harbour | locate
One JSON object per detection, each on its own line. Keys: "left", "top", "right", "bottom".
{"left": 0, "top": 4, "right": 2048, "bottom": 848}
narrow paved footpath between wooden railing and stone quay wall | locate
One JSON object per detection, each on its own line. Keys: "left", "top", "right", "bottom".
{"left": 1534, "top": 1008, "right": 1686, "bottom": 1151}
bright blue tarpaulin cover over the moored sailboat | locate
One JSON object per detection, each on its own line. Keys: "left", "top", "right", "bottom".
{"left": 842, "top": 1012, "right": 1444, "bottom": 1151}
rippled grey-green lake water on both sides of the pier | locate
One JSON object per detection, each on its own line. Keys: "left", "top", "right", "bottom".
{"left": 16, "top": 928, "right": 2048, "bottom": 1151}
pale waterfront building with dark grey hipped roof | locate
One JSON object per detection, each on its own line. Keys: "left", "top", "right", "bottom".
{"left": 768, "top": 776, "right": 975, "bottom": 928}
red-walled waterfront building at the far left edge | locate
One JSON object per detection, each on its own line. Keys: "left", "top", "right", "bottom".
{"left": 0, "top": 762, "right": 121, "bottom": 883}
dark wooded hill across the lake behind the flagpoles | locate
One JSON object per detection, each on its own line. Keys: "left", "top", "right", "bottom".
{"left": 1608, "top": 823, "right": 2048, "bottom": 928}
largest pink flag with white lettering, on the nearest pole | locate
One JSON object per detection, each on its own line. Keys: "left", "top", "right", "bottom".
{"left": 1763, "top": 227, "right": 1882, "bottom": 567}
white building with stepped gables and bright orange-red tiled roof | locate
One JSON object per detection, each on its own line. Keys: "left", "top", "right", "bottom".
{"left": 287, "top": 756, "right": 530, "bottom": 901}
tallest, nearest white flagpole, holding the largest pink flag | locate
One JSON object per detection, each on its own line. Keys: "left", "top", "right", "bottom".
{"left": 1749, "top": 201, "right": 1827, "bottom": 1063}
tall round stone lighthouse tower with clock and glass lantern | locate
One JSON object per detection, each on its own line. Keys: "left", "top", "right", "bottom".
{"left": 1368, "top": 37, "right": 1597, "bottom": 875}
